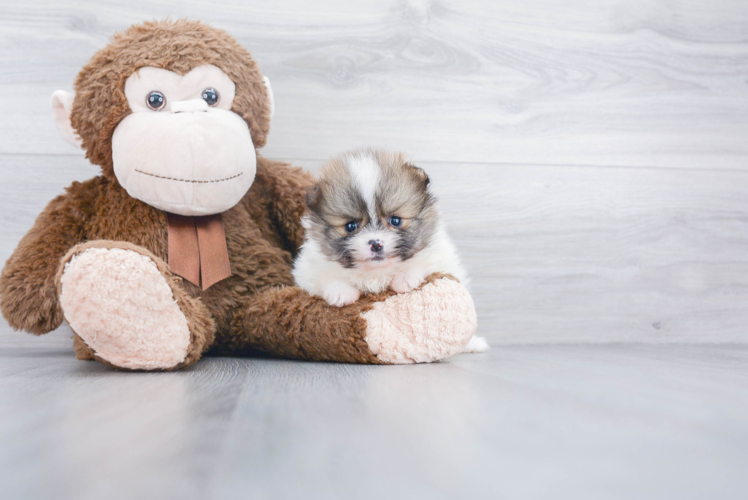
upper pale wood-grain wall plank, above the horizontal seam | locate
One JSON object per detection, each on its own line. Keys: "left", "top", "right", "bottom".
{"left": 0, "top": 0, "right": 748, "bottom": 170}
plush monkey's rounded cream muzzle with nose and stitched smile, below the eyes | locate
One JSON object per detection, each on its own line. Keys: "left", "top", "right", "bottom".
{"left": 112, "top": 107, "right": 257, "bottom": 215}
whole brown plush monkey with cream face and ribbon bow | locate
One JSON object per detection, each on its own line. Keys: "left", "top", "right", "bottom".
{"left": 0, "top": 21, "right": 476, "bottom": 370}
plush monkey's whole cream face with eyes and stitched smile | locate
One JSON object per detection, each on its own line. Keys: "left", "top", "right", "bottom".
{"left": 112, "top": 66, "right": 257, "bottom": 215}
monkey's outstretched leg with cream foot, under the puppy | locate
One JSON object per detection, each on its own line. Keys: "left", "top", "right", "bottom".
{"left": 225, "top": 275, "right": 477, "bottom": 364}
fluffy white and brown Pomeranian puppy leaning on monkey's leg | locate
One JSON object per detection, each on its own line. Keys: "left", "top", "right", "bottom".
{"left": 293, "top": 150, "right": 488, "bottom": 352}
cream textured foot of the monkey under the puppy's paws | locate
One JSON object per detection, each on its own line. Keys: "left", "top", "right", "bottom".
{"left": 361, "top": 278, "right": 478, "bottom": 364}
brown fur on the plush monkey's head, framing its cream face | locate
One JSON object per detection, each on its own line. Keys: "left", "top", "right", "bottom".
{"left": 71, "top": 20, "right": 271, "bottom": 179}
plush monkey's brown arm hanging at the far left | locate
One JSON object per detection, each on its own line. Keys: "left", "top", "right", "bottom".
{"left": 0, "top": 180, "right": 95, "bottom": 335}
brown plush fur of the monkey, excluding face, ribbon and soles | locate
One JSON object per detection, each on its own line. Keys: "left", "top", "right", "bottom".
{"left": 0, "top": 21, "right": 404, "bottom": 368}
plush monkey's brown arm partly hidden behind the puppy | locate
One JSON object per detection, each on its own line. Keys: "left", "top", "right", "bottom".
{"left": 250, "top": 156, "right": 314, "bottom": 256}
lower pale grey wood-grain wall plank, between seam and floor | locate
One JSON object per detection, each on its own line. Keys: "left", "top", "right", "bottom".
{"left": 0, "top": 155, "right": 748, "bottom": 344}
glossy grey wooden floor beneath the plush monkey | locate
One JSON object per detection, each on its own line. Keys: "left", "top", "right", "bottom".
{"left": 0, "top": 331, "right": 748, "bottom": 500}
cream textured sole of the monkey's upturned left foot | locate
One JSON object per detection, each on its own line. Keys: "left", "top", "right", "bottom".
{"left": 60, "top": 248, "right": 190, "bottom": 370}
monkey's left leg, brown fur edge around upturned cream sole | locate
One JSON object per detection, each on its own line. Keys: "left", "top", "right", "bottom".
{"left": 57, "top": 240, "right": 216, "bottom": 370}
